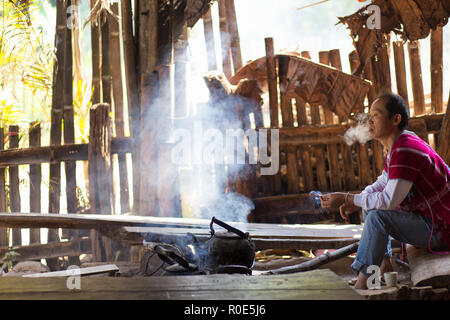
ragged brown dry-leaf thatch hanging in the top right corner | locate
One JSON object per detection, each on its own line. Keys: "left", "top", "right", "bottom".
{"left": 339, "top": 0, "right": 450, "bottom": 74}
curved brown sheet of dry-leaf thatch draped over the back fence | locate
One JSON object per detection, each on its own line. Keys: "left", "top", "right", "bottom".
{"left": 230, "top": 53, "right": 370, "bottom": 118}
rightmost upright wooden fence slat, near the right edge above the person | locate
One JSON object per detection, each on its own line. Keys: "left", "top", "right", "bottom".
{"left": 430, "top": 27, "right": 444, "bottom": 113}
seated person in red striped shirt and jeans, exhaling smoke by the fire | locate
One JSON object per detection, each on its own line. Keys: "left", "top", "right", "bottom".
{"left": 321, "top": 93, "right": 450, "bottom": 289}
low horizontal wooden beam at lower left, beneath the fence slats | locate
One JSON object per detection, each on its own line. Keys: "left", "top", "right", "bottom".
{"left": 0, "top": 238, "right": 91, "bottom": 263}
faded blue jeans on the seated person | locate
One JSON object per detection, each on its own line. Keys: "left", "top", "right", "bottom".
{"left": 351, "top": 209, "right": 441, "bottom": 276}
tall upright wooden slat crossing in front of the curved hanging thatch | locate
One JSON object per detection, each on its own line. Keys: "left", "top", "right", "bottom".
{"left": 264, "top": 38, "right": 280, "bottom": 128}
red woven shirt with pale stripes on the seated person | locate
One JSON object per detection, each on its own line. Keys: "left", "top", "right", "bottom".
{"left": 385, "top": 132, "right": 450, "bottom": 248}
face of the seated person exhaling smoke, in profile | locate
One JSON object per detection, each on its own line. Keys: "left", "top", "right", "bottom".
{"left": 369, "top": 99, "right": 401, "bottom": 140}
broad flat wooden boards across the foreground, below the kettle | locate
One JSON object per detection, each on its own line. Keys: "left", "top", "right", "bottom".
{"left": 0, "top": 269, "right": 364, "bottom": 300}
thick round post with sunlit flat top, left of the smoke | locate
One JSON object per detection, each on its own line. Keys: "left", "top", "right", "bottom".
{"left": 88, "top": 103, "right": 113, "bottom": 261}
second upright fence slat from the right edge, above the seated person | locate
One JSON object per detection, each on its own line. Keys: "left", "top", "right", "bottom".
{"left": 408, "top": 41, "right": 425, "bottom": 116}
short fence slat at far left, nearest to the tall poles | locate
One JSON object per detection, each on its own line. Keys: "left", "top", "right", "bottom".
{"left": 28, "top": 122, "right": 41, "bottom": 244}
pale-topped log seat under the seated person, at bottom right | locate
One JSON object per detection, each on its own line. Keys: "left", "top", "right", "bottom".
{"left": 407, "top": 246, "right": 450, "bottom": 287}
